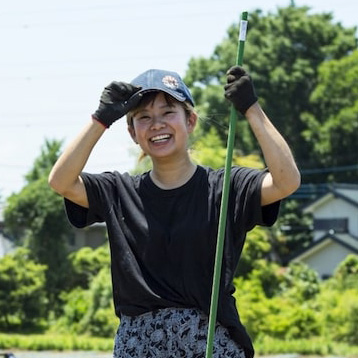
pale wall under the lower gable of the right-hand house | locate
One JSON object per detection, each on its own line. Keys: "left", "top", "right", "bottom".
{"left": 300, "top": 240, "right": 352, "bottom": 278}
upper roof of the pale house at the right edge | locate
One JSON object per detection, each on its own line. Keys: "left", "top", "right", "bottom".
{"left": 303, "top": 183, "right": 358, "bottom": 213}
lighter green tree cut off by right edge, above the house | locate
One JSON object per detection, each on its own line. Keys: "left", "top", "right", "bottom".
{"left": 303, "top": 50, "right": 358, "bottom": 183}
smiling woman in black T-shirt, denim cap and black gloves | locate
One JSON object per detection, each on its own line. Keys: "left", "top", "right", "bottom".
{"left": 49, "top": 67, "right": 300, "bottom": 358}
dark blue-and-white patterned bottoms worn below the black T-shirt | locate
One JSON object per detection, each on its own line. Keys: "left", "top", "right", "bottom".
{"left": 113, "top": 308, "right": 245, "bottom": 358}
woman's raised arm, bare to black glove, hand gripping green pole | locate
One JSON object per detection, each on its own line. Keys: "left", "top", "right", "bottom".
{"left": 225, "top": 66, "right": 301, "bottom": 205}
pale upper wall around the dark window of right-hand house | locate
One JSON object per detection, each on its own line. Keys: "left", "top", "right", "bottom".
{"left": 314, "top": 198, "right": 358, "bottom": 240}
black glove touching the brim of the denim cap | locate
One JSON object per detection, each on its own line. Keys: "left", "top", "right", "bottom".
{"left": 92, "top": 81, "right": 141, "bottom": 128}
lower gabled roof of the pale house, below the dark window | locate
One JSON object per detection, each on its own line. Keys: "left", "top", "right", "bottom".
{"left": 289, "top": 232, "right": 358, "bottom": 261}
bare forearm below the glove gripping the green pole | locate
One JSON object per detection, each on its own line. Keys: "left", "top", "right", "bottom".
{"left": 245, "top": 102, "right": 300, "bottom": 197}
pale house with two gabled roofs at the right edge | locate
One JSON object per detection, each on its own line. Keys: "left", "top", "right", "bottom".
{"left": 291, "top": 184, "right": 358, "bottom": 278}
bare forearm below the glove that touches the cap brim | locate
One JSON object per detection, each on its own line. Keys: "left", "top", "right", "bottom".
{"left": 49, "top": 120, "right": 105, "bottom": 196}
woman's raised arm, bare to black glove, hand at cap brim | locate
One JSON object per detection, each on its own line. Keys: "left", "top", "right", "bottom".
{"left": 48, "top": 82, "right": 140, "bottom": 207}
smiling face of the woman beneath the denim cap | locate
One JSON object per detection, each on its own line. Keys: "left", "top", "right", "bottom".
{"left": 128, "top": 92, "right": 197, "bottom": 159}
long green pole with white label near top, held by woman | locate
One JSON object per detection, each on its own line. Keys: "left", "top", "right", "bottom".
{"left": 205, "top": 11, "right": 247, "bottom": 358}
